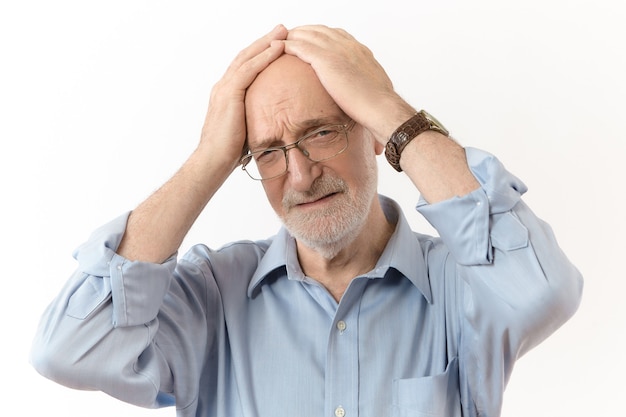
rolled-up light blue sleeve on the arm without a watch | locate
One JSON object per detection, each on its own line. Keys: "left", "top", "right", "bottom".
{"left": 31, "top": 213, "right": 176, "bottom": 407}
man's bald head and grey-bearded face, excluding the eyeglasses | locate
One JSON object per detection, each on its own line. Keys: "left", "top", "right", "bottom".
{"left": 245, "top": 55, "right": 381, "bottom": 257}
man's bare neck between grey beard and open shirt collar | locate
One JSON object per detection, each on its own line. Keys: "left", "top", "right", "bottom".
{"left": 297, "top": 197, "right": 394, "bottom": 302}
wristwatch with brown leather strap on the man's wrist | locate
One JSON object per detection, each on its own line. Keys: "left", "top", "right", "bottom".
{"left": 385, "top": 110, "right": 450, "bottom": 172}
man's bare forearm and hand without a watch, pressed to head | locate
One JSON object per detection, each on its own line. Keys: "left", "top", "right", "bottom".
{"left": 117, "top": 25, "right": 287, "bottom": 263}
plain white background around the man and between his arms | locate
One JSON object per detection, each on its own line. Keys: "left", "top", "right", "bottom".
{"left": 0, "top": 0, "right": 626, "bottom": 417}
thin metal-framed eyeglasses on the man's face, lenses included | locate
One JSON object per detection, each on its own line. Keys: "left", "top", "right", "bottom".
{"left": 240, "top": 120, "right": 355, "bottom": 181}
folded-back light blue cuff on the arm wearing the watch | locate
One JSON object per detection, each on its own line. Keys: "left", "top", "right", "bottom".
{"left": 416, "top": 148, "right": 527, "bottom": 265}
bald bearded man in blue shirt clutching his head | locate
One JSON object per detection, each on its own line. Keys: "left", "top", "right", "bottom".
{"left": 32, "top": 26, "right": 582, "bottom": 417}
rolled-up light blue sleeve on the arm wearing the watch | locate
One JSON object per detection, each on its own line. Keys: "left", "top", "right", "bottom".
{"left": 417, "top": 148, "right": 582, "bottom": 415}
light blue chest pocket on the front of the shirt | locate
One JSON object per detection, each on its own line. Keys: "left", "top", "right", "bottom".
{"left": 392, "top": 357, "right": 461, "bottom": 417}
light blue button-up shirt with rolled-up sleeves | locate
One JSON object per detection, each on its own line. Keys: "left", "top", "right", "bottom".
{"left": 32, "top": 148, "right": 582, "bottom": 417}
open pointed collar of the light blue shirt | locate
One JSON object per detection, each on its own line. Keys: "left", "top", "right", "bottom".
{"left": 248, "top": 195, "right": 432, "bottom": 303}
